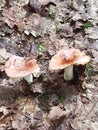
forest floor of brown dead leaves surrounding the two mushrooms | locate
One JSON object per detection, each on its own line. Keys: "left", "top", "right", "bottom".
{"left": 0, "top": 0, "right": 98, "bottom": 130}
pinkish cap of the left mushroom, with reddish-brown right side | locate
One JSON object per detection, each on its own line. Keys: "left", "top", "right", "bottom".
{"left": 5, "top": 55, "right": 40, "bottom": 78}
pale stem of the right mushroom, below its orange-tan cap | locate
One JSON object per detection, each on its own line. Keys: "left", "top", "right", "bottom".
{"left": 64, "top": 65, "right": 74, "bottom": 81}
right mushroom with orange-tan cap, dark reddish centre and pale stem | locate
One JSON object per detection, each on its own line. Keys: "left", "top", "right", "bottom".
{"left": 49, "top": 48, "right": 90, "bottom": 81}
